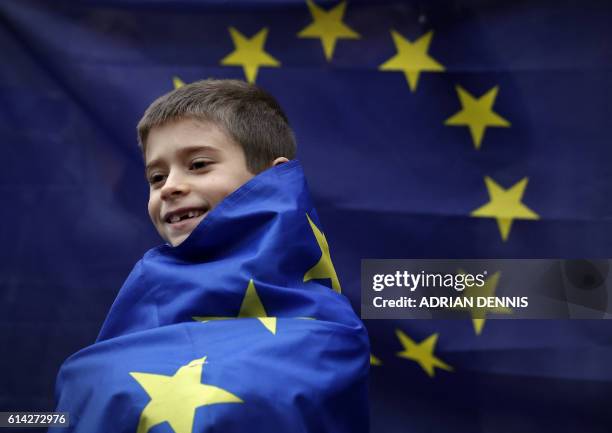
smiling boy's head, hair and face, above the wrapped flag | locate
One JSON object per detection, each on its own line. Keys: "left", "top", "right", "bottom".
{"left": 138, "top": 80, "right": 296, "bottom": 246}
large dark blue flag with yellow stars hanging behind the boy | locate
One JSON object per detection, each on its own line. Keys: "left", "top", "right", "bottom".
{"left": 0, "top": 0, "right": 612, "bottom": 433}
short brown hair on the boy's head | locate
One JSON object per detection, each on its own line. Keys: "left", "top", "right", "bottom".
{"left": 137, "top": 79, "right": 296, "bottom": 173}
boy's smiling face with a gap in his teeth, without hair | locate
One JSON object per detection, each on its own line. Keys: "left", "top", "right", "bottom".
{"left": 145, "top": 119, "right": 254, "bottom": 246}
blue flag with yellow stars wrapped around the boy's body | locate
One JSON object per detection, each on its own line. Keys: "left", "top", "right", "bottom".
{"left": 50, "top": 161, "right": 369, "bottom": 433}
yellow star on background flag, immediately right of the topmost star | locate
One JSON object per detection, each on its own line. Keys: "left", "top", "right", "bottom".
{"left": 378, "top": 30, "right": 445, "bottom": 92}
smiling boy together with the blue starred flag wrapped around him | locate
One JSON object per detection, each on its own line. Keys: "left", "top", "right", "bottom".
{"left": 50, "top": 80, "right": 369, "bottom": 433}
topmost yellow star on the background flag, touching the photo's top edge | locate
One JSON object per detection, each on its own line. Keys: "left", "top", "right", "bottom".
{"left": 298, "top": 0, "right": 361, "bottom": 62}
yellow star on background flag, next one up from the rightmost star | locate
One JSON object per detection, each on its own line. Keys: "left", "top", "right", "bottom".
{"left": 444, "top": 86, "right": 510, "bottom": 150}
